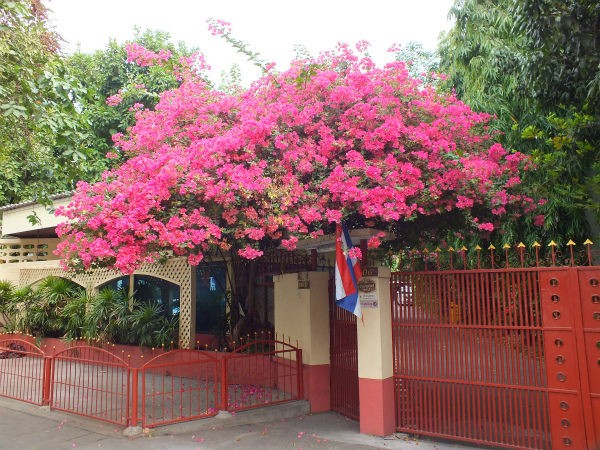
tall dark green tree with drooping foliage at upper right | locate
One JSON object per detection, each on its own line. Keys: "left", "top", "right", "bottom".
{"left": 439, "top": 0, "right": 600, "bottom": 246}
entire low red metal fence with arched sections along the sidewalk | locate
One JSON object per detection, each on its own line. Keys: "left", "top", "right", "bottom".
{"left": 0, "top": 335, "right": 304, "bottom": 427}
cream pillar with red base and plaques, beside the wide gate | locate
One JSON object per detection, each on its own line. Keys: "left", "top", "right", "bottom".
{"left": 356, "top": 267, "right": 396, "bottom": 436}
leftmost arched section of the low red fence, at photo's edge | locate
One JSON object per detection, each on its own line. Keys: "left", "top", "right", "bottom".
{"left": 0, "top": 336, "right": 50, "bottom": 405}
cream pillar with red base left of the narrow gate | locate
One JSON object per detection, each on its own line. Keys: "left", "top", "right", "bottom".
{"left": 274, "top": 272, "right": 331, "bottom": 412}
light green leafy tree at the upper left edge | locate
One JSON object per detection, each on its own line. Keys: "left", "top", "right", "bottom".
{"left": 0, "top": 0, "right": 97, "bottom": 205}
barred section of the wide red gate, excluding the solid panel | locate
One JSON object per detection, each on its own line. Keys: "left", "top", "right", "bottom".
{"left": 391, "top": 269, "right": 550, "bottom": 449}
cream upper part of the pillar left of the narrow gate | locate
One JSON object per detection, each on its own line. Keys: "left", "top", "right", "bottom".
{"left": 274, "top": 272, "right": 329, "bottom": 365}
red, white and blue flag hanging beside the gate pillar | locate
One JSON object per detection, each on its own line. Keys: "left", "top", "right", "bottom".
{"left": 335, "top": 223, "right": 362, "bottom": 318}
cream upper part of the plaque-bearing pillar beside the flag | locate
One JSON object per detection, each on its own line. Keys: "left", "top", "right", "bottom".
{"left": 356, "top": 267, "right": 394, "bottom": 380}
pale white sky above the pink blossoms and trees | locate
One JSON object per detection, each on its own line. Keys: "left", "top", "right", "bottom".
{"left": 45, "top": 0, "right": 454, "bottom": 83}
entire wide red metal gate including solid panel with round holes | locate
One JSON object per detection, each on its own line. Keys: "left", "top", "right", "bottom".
{"left": 391, "top": 258, "right": 600, "bottom": 449}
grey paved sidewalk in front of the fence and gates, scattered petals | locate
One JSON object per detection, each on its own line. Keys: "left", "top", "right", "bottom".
{"left": 0, "top": 398, "right": 477, "bottom": 450}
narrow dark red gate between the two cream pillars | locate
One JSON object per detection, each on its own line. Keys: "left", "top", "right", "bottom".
{"left": 329, "top": 281, "right": 360, "bottom": 420}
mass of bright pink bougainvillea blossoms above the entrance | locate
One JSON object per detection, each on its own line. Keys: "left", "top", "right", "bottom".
{"left": 58, "top": 45, "right": 532, "bottom": 272}
